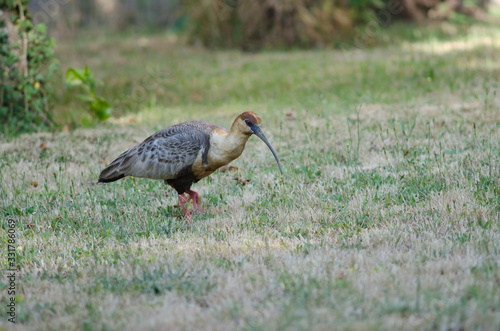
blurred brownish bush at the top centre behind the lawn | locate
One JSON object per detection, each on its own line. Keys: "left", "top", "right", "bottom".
{"left": 183, "top": 0, "right": 383, "bottom": 49}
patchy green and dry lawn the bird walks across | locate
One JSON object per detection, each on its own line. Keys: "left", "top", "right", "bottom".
{"left": 0, "top": 22, "right": 500, "bottom": 330}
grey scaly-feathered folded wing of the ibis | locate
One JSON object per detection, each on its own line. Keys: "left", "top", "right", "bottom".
{"left": 100, "top": 122, "right": 214, "bottom": 179}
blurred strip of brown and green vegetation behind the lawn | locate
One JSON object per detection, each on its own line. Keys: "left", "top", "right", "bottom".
{"left": 29, "top": 0, "right": 496, "bottom": 49}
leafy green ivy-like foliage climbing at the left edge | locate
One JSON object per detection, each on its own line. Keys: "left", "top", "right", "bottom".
{"left": 0, "top": 0, "right": 58, "bottom": 136}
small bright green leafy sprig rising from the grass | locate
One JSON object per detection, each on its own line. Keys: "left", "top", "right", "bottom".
{"left": 66, "top": 66, "right": 112, "bottom": 124}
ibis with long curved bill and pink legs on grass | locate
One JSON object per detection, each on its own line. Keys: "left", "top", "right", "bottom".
{"left": 99, "top": 111, "right": 283, "bottom": 223}
